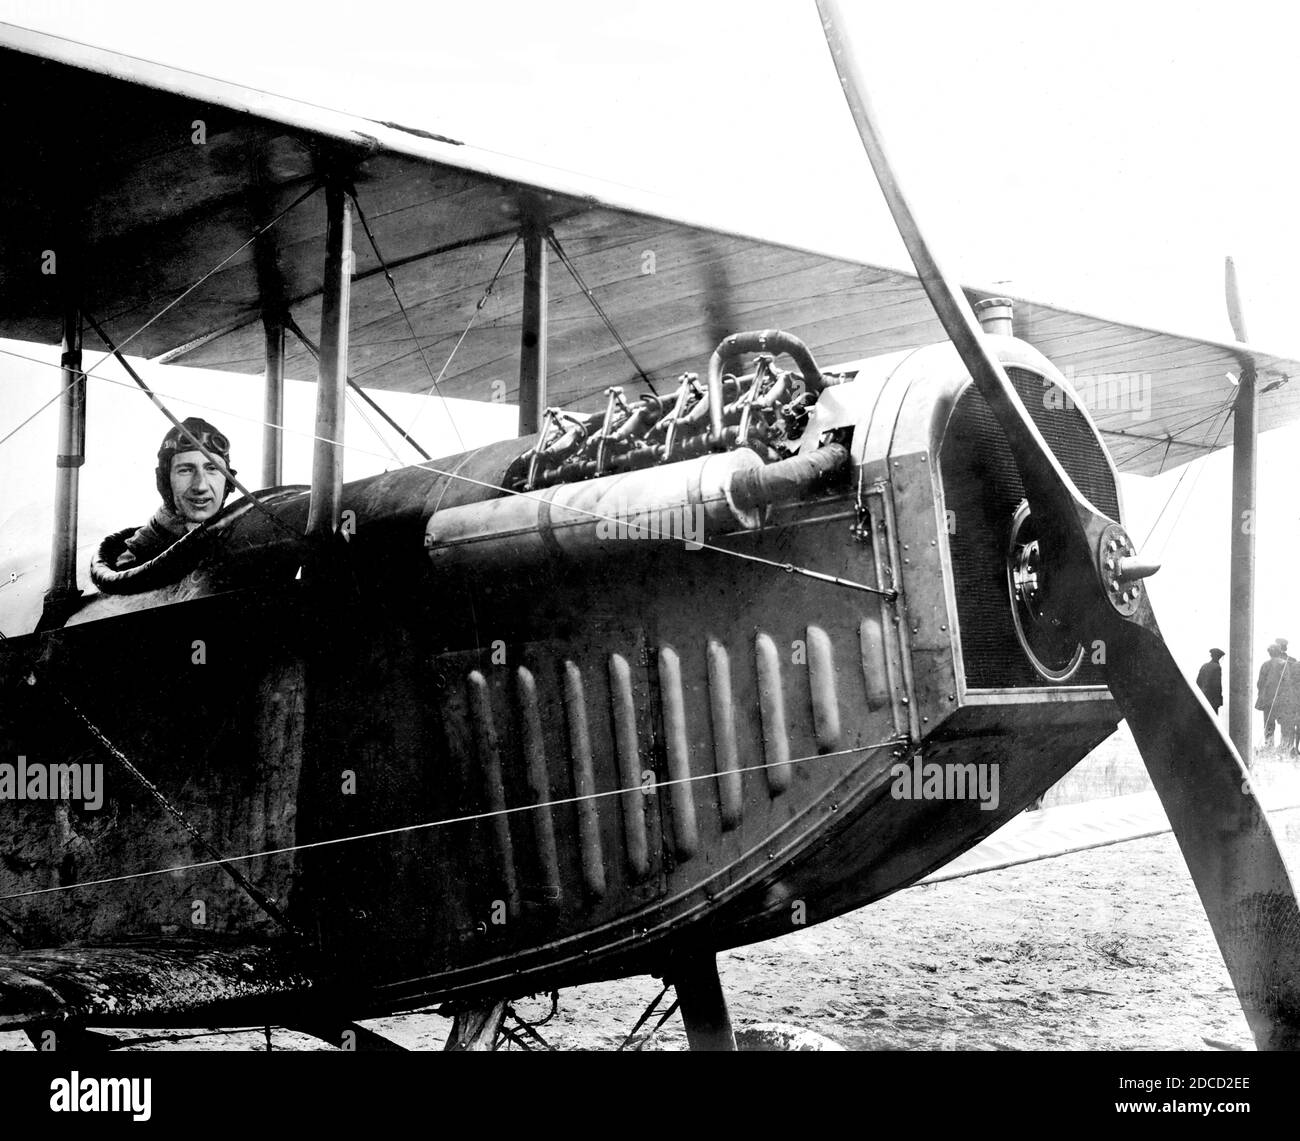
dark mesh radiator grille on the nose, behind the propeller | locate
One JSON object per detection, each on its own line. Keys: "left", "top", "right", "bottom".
{"left": 940, "top": 368, "right": 1119, "bottom": 689}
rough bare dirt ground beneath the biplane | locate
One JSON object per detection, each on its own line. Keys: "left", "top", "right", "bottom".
{"left": 0, "top": 762, "right": 1300, "bottom": 1050}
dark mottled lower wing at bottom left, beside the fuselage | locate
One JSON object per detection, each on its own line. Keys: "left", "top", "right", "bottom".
{"left": 0, "top": 940, "right": 311, "bottom": 1031}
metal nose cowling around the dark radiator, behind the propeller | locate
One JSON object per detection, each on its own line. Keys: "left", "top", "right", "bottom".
{"left": 802, "top": 335, "right": 1119, "bottom": 734}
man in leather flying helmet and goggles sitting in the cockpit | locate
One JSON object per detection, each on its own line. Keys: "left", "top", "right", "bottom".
{"left": 114, "top": 416, "right": 235, "bottom": 571}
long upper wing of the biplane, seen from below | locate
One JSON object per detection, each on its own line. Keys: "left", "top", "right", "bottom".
{"left": 0, "top": 25, "right": 1300, "bottom": 473}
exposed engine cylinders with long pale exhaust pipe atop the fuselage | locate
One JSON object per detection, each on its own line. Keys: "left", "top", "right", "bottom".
{"left": 425, "top": 329, "right": 849, "bottom": 571}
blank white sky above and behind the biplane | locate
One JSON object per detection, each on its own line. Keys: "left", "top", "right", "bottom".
{"left": 0, "top": 0, "right": 1300, "bottom": 672}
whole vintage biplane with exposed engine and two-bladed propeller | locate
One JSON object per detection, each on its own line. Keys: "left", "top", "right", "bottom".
{"left": 0, "top": 3, "right": 1300, "bottom": 1049}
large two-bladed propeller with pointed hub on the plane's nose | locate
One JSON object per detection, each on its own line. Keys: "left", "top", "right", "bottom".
{"left": 816, "top": 0, "right": 1300, "bottom": 1050}
